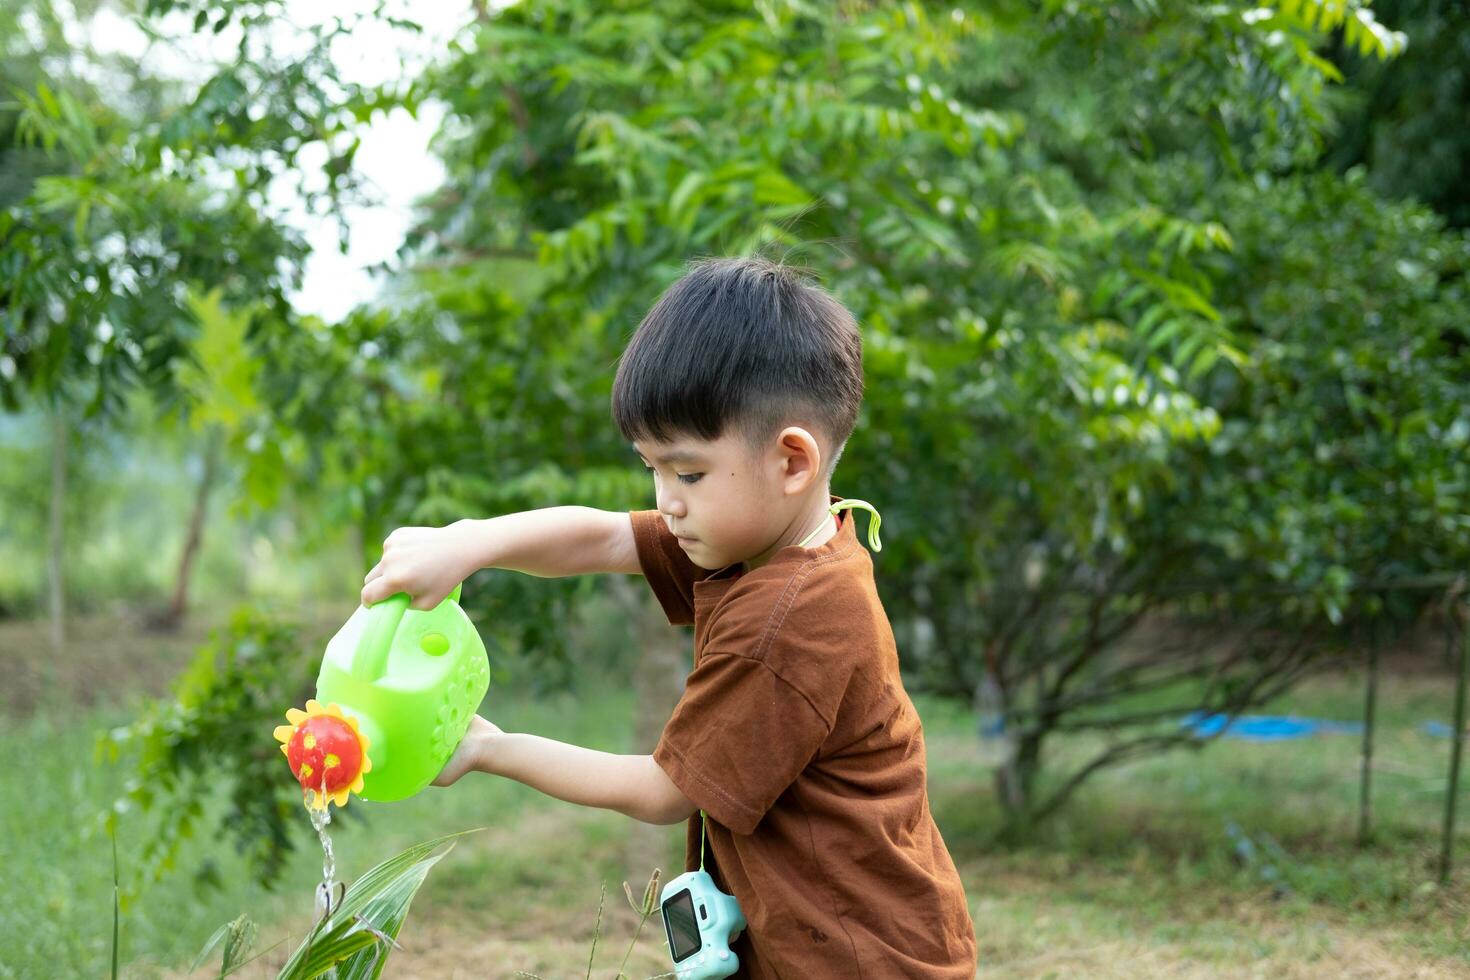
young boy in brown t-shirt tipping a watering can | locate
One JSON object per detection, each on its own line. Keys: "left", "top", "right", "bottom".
{"left": 362, "top": 259, "right": 976, "bottom": 980}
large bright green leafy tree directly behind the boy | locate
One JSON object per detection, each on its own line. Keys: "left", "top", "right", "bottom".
{"left": 376, "top": 1, "right": 1446, "bottom": 813}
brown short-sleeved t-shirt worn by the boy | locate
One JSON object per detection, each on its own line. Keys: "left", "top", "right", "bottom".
{"left": 631, "top": 497, "right": 976, "bottom": 980}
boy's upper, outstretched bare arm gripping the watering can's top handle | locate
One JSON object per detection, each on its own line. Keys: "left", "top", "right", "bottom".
{"left": 362, "top": 507, "right": 642, "bottom": 610}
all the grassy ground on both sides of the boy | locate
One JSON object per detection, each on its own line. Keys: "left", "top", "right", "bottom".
{"left": 0, "top": 614, "right": 1470, "bottom": 980}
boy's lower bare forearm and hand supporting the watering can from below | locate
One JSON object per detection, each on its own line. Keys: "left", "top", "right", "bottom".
{"left": 434, "top": 716, "right": 697, "bottom": 824}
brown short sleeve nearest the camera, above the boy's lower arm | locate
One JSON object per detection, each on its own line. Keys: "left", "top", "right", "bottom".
{"left": 653, "top": 649, "right": 832, "bottom": 835}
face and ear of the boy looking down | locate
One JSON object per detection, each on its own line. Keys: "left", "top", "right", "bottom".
{"left": 634, "top": 426, "right": 828, "bottom": 570}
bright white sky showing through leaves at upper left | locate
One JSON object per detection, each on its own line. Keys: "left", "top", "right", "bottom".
{"left": 80, "top": 0, "right": 476, "bottom": 320}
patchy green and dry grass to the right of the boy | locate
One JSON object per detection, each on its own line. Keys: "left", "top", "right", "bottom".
{"left": 926, "top": 673, "right": 1470, "bottom": 977}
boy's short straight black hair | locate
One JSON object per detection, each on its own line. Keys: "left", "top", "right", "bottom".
{"left": 613, "top": 256, "right": 863, "bottom": 476}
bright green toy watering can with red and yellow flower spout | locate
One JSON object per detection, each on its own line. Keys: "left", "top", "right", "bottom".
{"left": 275, "top": 585, "right": 490, "bottom": 810}
